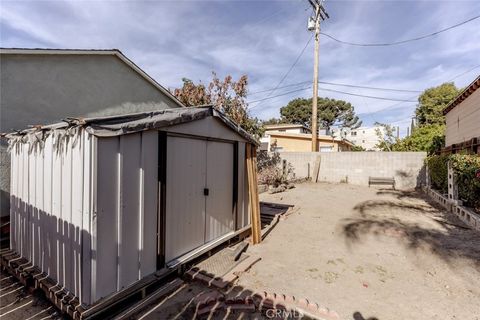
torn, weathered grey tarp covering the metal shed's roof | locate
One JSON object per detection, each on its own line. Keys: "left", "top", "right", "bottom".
{"left": 6, "top": 106, "right": 259, "bottom": 145}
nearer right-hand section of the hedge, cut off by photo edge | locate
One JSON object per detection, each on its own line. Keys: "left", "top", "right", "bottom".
{"left": 450, "top": 154, "right": 480, "bottom": 211}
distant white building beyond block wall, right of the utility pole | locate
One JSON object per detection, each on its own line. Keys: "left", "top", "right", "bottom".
{"left": 330, "top": 126, "right": 385, "bottom": 151}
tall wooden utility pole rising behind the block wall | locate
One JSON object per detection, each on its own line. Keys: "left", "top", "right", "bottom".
{"left": 308, "top": 0, "right": 329, "bottom": 152}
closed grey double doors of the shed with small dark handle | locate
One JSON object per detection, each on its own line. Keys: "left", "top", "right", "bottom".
{"left": 165, "top": 136, "right": 234, "bottom": 262}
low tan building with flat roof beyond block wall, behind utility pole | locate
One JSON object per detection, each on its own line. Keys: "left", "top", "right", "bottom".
{"left": 268, "top": 132, "right": 353, "bottom": 152}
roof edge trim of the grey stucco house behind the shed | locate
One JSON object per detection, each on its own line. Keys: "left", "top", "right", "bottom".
{"left": 0, "top": 48, "right": 185, "bottom": 107}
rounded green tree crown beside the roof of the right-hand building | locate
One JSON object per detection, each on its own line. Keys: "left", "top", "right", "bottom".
{"left": 415, "top": 82, "right": 460, "bottom": 126}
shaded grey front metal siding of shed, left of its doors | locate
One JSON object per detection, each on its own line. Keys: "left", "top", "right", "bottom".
{"left": 92, "top": 131, "right": 158, "bottom": 301}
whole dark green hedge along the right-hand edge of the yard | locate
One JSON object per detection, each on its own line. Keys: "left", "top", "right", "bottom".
{"left": 426, "top": 154, "right": 480, "bottom": 212}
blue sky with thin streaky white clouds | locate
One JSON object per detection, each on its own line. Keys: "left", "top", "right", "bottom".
{"left": 0, "top": 0, "right": 480, "bottom": 134}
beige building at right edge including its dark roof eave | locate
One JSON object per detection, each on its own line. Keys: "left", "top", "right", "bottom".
{"left": 443, "top": 76, "right": 480, "bottom": 152}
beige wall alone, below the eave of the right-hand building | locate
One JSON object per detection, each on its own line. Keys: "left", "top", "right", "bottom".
{"left": 445, "top": 90, "right": 480, "bottom": 147}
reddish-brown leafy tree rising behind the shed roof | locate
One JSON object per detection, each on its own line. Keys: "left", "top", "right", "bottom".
{"left": 173, "top": 72, "right": 264, "bottom": 139}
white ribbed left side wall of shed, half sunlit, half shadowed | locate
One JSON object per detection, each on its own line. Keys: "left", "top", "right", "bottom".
{"left": 11, "top": 133, "right": 89, "bottom": 296}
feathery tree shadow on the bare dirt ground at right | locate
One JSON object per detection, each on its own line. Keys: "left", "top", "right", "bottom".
{"left": 342, "top": 190, "right": 480, "bottom": 269}
